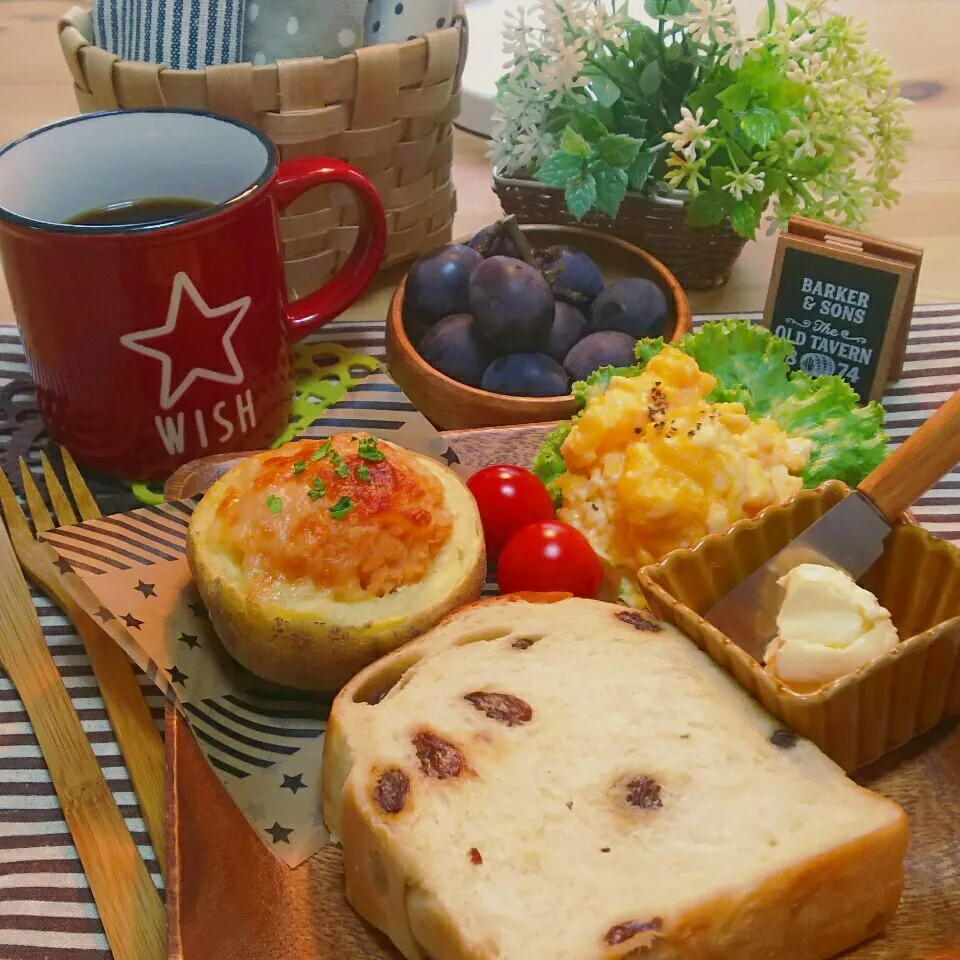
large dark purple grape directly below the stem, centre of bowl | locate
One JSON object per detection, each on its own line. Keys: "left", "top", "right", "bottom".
{"left": 470, "top": 257, "right": 555, "bottom": 353}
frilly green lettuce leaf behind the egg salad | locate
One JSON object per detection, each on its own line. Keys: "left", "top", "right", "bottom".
{"left": 534, "top": 318, "right": 887, "bottom": 496}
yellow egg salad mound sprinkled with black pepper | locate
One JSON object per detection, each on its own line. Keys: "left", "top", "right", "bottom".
{"left": 558, "top": 347, "right": 812, "bottom": 575}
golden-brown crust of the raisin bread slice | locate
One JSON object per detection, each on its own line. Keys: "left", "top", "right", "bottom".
{"left": 323, "top": 597, "right": 908, "bottom": 960}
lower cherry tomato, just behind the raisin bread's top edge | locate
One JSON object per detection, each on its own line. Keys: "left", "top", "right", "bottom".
{"left": 497, "top": 520, "right": 603, "bottom": 598}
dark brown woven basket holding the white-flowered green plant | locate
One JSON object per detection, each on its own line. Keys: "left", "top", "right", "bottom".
{"left": 493, "top": 171, "right": 747, "bottom": 290}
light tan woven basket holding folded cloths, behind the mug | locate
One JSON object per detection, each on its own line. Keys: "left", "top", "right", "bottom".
{"left": 59, "top": 7, "right": 467, "bottom": 296}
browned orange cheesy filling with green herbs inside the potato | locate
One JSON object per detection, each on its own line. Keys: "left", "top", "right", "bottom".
{"left": 215, "top": 434, "right": 453, "bottom": 602}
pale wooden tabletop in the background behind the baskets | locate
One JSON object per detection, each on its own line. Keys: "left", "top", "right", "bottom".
{"left": 0, "top": 0, "right": 960, "bottom": 324}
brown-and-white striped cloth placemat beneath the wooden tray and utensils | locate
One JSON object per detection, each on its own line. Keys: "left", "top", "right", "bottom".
{"left": 0, "top": 312, "right": 960, "bottom": 960}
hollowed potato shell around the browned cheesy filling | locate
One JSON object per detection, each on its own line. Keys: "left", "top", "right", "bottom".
{"left": 187, "top": 441, "right": 486, "bottom": 691}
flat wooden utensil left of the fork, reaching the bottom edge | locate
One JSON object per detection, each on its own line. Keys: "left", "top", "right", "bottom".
{"left": 0, "top": 492, "right": 165, "bottom": 960}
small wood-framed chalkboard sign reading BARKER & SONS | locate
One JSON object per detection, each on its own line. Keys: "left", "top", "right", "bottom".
{"left": 764, "top": 217, "right": 922, "bottom": 402}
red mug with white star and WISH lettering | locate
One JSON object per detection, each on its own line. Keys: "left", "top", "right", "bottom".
{"left": 0, "top": 110, "right": 386, "bottom": 480}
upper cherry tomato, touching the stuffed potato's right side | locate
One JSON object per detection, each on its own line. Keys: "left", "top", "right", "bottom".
{"left": 467, "top": 464, "right": 553, "bottom": 560}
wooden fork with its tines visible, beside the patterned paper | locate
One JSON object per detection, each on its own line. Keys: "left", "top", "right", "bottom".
{"left": 0, "top": 448, "right": 167, "bottom": 879}
